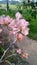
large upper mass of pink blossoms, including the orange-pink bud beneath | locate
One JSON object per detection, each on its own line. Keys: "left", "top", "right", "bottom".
{"left": 0, "top": 12, "right": 29, "bottom": 40}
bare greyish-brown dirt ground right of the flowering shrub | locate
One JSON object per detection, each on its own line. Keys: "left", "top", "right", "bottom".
{"left": 17, "top": 37, "right": 37, "bottom": 65}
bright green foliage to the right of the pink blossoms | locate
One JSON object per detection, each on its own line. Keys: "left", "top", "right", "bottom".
{"left": 22, "top": 9, "right": 37, "bottom": 40}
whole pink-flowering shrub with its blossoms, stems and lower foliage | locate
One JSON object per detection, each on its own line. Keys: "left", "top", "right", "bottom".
{"left": 0, "top": 12, "right": 29, "bottom": 65}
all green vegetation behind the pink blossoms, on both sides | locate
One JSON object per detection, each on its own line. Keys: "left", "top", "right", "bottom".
{"left": 0, "top": 9, "right": 37, "bottom": 40}
